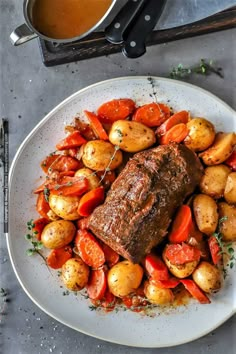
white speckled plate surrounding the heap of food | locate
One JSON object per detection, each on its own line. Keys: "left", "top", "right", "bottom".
{"left": 8, "top": 77, "right": 236, "bottom": 347}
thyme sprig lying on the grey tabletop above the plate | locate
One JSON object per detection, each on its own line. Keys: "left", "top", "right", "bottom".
{"left": 170, "top": 59, "right": 224, "bottom": 79}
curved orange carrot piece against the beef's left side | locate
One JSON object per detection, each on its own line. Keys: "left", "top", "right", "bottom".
{"left": 78, "top": 187, "right": 105, "bottom": 216}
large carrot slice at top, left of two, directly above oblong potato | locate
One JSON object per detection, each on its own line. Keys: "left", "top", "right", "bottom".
{"left": 97, "top": 98, "right": 135, "bottom": 123}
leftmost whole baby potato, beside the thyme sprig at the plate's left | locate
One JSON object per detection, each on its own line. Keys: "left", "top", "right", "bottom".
{"left": 41, "top": 220, "right": 76, "bottom": 248}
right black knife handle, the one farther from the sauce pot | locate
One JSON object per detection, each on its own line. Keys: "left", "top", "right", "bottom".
{"left": 123, "top": 0, "right": 166, "bottom": 58}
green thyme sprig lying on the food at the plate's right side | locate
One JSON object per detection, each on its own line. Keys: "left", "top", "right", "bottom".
{"left": 213, "top": 216, "right": 236, "bottom": 278}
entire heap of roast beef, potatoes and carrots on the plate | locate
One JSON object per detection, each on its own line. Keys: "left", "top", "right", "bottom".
{"left": 27, "top": 98, "right": 236, "bottom": 311}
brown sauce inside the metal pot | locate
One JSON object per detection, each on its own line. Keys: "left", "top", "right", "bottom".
{"left": 32, "top": 0, "right": 112, "bottom": 39}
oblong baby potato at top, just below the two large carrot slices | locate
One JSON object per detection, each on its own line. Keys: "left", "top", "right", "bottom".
{"left": 109, "top": 120, "right": 156, "bottom": 152}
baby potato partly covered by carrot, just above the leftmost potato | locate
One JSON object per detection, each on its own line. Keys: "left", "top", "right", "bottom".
{"left": 49, "top": 195, "right": 80, "bottom": 220}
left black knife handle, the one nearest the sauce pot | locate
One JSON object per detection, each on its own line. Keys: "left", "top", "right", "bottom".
{"left": 105, "top": 0, "right": 148, "bottom": 44}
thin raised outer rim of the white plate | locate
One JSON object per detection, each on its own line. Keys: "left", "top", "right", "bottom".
{"left": 6, "top": 75, "right": 236, "bottom": 348}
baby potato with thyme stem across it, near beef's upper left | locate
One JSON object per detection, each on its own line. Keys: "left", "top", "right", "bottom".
{"left": 82, "top": 140, "right": 123, "bottom": 171}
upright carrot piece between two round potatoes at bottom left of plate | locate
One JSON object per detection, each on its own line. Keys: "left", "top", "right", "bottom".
{"left": 86, "top": 268, "right": 107, "bottom": 300}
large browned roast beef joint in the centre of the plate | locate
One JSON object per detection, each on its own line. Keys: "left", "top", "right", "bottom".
{"left": 89, "top": 144, "right": 203, "bottom": 263}
